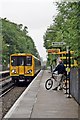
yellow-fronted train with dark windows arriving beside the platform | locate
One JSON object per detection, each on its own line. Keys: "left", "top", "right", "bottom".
{"left": 10, "top": 53, "right": 41, "bottom": 83}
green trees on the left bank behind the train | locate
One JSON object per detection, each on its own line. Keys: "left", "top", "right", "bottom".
{"left": 0, "top": 18, "right": 39, "bottom": 69}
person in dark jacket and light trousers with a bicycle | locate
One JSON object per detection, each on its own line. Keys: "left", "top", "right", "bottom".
{"left": 53, "top": 60, "right": 66, "bottom": 90}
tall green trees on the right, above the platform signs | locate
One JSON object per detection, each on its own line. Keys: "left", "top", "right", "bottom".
{"left": 43, "top": 1, "right": 80, "bottom": 66}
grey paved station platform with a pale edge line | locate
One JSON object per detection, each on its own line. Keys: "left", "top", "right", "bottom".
{"left": 4, "top": 70, "right": 79, "bottom": 120}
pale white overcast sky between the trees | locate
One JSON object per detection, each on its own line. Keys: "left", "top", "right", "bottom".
{"left": 0, "top": 0, "right": 58, "bottom": 60}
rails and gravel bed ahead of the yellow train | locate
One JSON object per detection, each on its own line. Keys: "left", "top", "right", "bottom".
{"left": 0, "top": 77, "right": 28, "bottom": 118}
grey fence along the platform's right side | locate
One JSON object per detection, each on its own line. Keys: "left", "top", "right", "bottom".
{"left": 70, "top": 68, "right": 80, "bottom": 104}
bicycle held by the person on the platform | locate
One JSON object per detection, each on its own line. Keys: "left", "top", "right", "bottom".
{"left": 45, "top": 73, "right": 68, "bottom": 90}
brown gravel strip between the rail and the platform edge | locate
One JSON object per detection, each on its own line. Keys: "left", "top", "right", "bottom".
{"left": 2, "top": 86, "right": 26, "bottom": 117}
